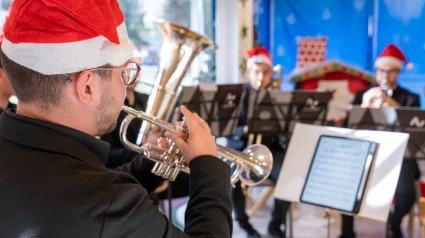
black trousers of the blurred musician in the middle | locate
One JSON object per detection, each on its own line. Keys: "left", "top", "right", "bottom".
{"left": 232, "top": 149, "right": 291, "bottom": 227}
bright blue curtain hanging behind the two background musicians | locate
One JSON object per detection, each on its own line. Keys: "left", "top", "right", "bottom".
{"left": 254, "top": 0, "right": 425, "bottom": 106}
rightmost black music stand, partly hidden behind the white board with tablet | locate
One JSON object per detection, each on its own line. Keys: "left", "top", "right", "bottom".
{"left": 348, "top": 107, "right": 425, "bottom": 159}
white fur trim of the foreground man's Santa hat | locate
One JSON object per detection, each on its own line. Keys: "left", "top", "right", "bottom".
{"left": 2, "top": 22, "right": 134, "bottom": 75}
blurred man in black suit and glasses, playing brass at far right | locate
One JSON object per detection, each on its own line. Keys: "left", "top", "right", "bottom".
{"left": 341, "top": 44, "right": 420, "bottom": 238}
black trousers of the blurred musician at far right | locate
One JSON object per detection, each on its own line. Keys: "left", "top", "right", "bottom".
{"left": 341, "top": 159, "right": 420, "bottom": 238}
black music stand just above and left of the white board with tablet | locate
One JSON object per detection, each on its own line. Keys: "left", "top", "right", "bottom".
{"left": 248, "top": 90, "right": 333, "bottom": 144}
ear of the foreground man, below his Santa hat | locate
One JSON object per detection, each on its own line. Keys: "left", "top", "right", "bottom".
{"left": 75, "top": 70, "right": 96, "bottom": 104}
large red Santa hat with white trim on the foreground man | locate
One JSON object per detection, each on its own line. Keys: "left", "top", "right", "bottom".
{"left": 1, "top": 0, "right": 133, "bottom": 75}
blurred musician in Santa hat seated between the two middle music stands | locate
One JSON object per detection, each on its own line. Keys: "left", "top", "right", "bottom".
{"left": 228, "top": 47, "right": 290, "bottom": 237}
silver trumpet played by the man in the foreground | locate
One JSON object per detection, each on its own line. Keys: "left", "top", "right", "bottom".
{"left": 120, "top": 106, "right": 273, "bottom": 186}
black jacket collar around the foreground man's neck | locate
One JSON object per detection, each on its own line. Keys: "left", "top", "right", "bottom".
{"left": 0, "top": 109, "right": 109, "bottom": 165}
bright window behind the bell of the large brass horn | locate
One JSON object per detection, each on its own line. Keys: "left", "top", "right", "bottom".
{"left": 119, "top": 0, "right": 215, "bottom": 94}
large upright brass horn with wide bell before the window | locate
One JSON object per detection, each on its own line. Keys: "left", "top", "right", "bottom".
{"left": 136, "top": 19, "right": 216, "bottom": 145}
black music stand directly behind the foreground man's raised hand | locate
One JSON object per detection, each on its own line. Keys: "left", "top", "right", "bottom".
{"left": 172, "top": 84, "right": 245, "bottom": 137}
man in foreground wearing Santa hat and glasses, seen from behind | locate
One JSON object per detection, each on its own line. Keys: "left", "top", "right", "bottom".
{"left": 0, "top": 0, "right": 232, "bottom": 237}
